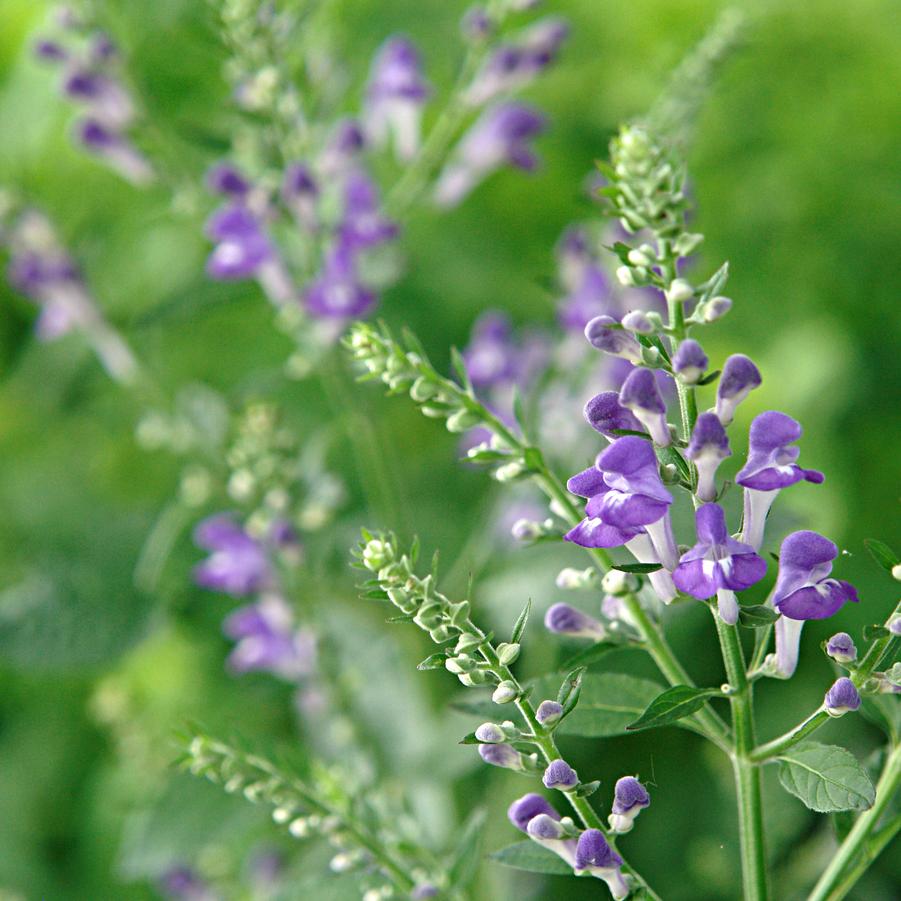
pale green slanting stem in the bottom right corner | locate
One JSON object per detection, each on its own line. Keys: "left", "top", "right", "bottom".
{"left": 808, "top": 744, "right": 901, "bottom": 901}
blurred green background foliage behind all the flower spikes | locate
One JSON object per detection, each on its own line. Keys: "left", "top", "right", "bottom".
{"left": 0, "top": 0, "right": 901, "bottom": 899}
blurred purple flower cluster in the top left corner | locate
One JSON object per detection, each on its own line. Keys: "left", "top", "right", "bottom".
{"left": 34, "top": 9, "right": 154, "bottom": 185}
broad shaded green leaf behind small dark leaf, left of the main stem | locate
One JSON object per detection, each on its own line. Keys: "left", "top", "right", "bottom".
{"left": 535, "top": 673, "right": 662, "bottom": 738}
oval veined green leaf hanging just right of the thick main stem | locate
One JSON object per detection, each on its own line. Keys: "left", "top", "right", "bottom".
{"left": 779, "top": 741, "right": 876, "bottom": 813}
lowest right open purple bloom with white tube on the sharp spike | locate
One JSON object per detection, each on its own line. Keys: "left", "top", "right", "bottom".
{"left": 768, "top": 531, "right": 858, "bottom": 679}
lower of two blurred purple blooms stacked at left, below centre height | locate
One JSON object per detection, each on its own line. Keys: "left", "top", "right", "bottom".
{"left": 222, "top": 595, "right": 316, "bottom": 682}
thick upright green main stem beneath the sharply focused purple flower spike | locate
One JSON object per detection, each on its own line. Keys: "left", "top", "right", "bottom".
{"left": 714, "top": 614, "right": 769, "bottom": 901}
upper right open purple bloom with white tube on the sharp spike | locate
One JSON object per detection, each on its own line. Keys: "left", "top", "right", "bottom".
{"left": 735, "top": 410, "right": 823, "bottom": 549}
